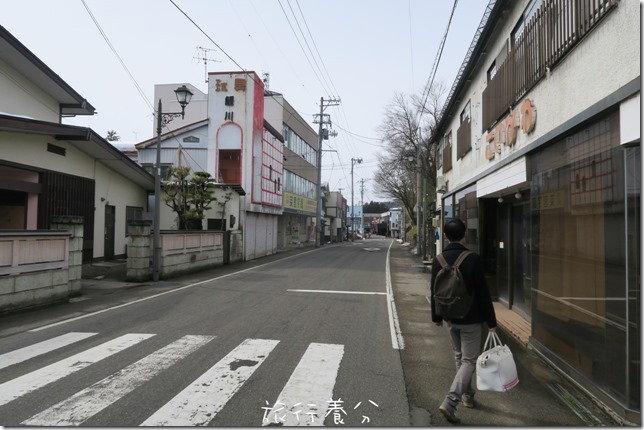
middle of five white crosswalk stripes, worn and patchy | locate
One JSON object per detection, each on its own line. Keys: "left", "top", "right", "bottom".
{"left": 21, "top": 336, "right": 215, "bottom": 427}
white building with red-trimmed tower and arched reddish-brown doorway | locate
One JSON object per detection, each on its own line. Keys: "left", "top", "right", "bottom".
{"left": 137, "top": 72, "right": 285, "bottom": 260}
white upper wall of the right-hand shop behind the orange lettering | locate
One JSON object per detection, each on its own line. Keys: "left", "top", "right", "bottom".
{"left": 439, "top": 0, "right": 640, "bottom": 190}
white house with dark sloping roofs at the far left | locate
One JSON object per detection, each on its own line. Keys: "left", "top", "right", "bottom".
{"left": 0, "top": 26, "right": 154, "bottom": 262}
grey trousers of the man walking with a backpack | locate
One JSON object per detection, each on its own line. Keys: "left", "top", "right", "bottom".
{"left": 445, "top": 322, "right": 483, "bottom": 408}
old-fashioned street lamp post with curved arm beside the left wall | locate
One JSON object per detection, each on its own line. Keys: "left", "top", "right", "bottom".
{"left": 152, "top": 85, "right": 192, "bottom": 282}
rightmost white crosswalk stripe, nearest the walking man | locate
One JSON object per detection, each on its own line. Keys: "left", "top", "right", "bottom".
{"left": 263, "top": 343, "right": 344, "bottom": 427}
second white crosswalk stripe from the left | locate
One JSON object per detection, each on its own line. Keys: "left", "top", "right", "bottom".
{"left": 0, "top": 334, "right": 154, "bottom": 405}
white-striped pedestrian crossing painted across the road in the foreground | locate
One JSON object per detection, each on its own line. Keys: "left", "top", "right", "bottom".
{"left": 0, "top": 332, "right": 344, "bottom": 427}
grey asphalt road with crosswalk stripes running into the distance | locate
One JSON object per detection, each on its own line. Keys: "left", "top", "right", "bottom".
{"left": 0, "top": 239, "right": 410, "bottom": 427}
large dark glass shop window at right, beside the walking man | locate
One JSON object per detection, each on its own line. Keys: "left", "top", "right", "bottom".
{"left": 530, "top": 112, "right": 641, "bottom": 410}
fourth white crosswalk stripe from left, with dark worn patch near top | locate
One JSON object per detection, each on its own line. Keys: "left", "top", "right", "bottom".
{"left": 141, "top": 339, "right": 279, "bottom": 427}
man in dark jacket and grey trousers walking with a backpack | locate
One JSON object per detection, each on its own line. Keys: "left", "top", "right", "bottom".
{"left": 430, "top": 218, "right": 496, "bottom": 423}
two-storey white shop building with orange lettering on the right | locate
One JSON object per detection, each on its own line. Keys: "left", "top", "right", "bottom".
{"left": 431, "top": 0, "right": 641, "bottom": 425}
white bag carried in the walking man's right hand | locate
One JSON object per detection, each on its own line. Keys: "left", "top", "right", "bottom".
{"left": 476, "top": 331, "right": 519, "bottom": 392}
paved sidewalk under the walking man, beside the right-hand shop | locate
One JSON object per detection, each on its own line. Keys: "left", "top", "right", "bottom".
{"left": 390, "top": 242, "right": 616, "bottom": 427}
